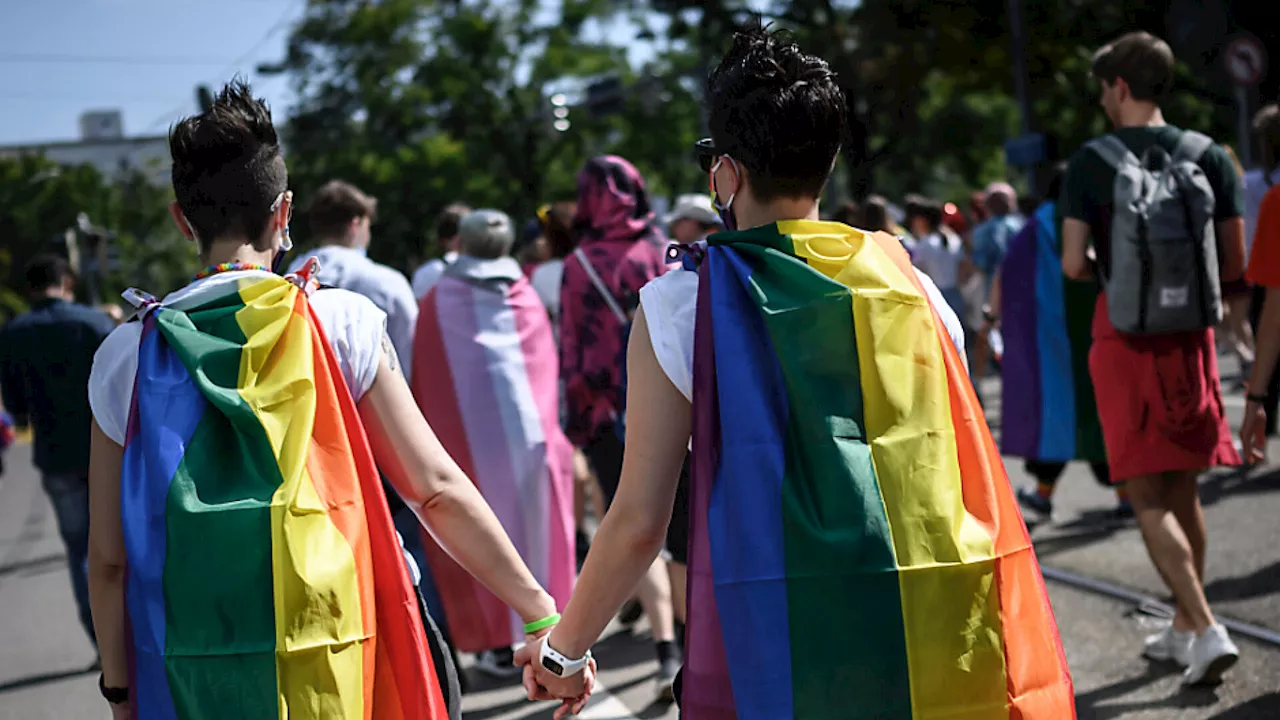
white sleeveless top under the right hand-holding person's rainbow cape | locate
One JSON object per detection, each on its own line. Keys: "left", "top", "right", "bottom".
{"left": 640, "top": 268, "right": 964, "bottom": 402}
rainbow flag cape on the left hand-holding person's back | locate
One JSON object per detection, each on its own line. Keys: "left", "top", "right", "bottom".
{"left": 120, "top": 277, "right": 448, "bottom": 720}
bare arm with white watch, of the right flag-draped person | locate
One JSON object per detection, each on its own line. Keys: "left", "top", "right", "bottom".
{"left": 548, "top": 309, "right": 692, "bottom": 657}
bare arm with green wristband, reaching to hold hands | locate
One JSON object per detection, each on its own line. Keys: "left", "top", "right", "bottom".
{"left": 357, "top": 336, "right": 556, "bottom": 623}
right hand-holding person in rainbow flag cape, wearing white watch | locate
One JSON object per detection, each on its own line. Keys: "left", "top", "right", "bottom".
{"left": 517, "top": 23, "right": 1075, "bottom": 720}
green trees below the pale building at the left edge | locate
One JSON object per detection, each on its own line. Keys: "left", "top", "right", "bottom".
{"left": 0, "top": 155, "right": 196, "bottom": 322}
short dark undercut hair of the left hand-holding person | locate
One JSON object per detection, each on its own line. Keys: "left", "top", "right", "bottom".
{"left": 169, "top": 78, "right": 289, "bottom": 250}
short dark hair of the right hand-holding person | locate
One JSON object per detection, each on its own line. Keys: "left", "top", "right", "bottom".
{"left": 707, "top": 20, "right": 846, "bottom": 201}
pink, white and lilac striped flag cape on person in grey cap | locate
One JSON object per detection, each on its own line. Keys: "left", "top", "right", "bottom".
{"left": 412, "top": 263, "right": 576, "bottom": 652}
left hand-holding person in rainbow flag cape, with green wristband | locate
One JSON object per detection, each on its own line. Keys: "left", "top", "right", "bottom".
{"left": 88, "top": 81, "right": 578, "bottom": 720}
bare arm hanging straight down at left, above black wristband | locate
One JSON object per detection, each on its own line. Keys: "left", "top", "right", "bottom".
{"left": 88, "top": 420, "right": 129, "bottom": 688}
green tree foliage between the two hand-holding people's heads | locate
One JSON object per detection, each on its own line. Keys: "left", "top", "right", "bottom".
{"left": 275, "top": 0, "right": 698, "bottom": 270}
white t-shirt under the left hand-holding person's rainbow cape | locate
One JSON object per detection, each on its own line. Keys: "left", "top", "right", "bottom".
{"left": 88, "top": 270, "right": 387, "bottom": 446}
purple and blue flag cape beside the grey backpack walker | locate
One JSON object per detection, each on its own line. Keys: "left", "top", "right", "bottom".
{"left": 1000, "top": 202, "right": 1107, "bottom": 461}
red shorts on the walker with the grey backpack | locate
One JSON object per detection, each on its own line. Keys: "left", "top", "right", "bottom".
{"left": 1089, "top": 293, "right": 1240, "bottom": 482}
